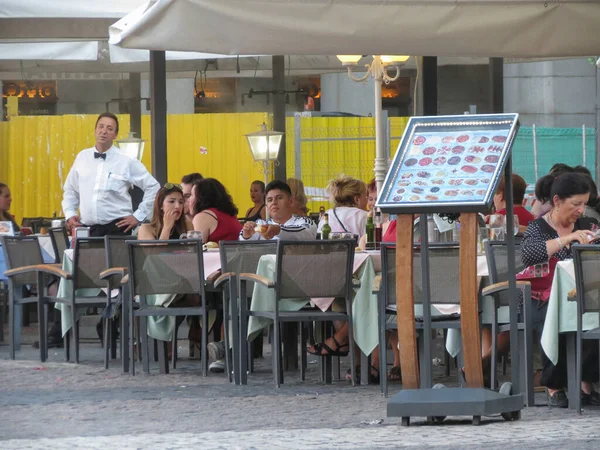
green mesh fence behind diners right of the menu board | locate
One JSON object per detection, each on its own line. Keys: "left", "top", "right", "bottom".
{"left": 513, "top": 127, "right": 596, "bottom": 188}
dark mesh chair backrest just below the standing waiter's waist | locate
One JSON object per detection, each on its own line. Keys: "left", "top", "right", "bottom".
{"left": 73, "top": 237, "right": 106, "bottom": 290}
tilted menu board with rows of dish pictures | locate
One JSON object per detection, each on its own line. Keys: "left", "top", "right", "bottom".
{"left": 377, "top": 114, "right": 518, "bottom": 213}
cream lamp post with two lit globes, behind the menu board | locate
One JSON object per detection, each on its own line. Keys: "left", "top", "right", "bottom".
{"left": 337, "top": 55, "right": 410, "bottom": 192}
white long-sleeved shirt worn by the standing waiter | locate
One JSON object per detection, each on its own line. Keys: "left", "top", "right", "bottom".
{"left": 62, "top": 145, "right": 160, "bottom": 225}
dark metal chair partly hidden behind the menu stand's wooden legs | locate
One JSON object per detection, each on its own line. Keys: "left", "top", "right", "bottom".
{"left": 373, "top": 243, "right": 460, "bottom": 397}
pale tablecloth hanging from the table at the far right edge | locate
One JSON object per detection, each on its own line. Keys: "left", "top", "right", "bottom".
{"left": 542, "top": 260, "right": 600, "bottom": 364}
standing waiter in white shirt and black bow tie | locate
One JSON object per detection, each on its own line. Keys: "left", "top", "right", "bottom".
{"left": 62, "top": 112, "right": 160, "bottom": 237}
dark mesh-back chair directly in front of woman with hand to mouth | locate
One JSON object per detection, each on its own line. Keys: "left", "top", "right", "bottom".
{"left": 127, "top": 239, "right": 208, "bottom": 376}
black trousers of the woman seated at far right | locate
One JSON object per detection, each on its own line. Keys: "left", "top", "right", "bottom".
{"left": 532, "top": 300, "right": 599, "bottom": 389}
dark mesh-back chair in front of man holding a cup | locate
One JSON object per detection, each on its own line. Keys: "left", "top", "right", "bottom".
{"left": 239, "top": 240, "right": 356, "bottom": 387}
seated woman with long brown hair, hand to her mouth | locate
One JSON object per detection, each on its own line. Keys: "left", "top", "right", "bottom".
{"left": 138, "top": 183, "right": 193, "bottom": 240}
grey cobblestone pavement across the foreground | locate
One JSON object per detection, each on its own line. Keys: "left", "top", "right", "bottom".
{"left": 0, "top": 344, "right": 600, "bottom": 450}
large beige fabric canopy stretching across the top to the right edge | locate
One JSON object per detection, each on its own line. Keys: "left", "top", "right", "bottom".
{"left": 110, "top": 0, "right": 600, "bottom": 57}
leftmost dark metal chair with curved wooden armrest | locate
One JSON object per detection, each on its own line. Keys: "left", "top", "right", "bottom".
{"left": 0, "top": 236, "right": 70, "bottom": 362}
